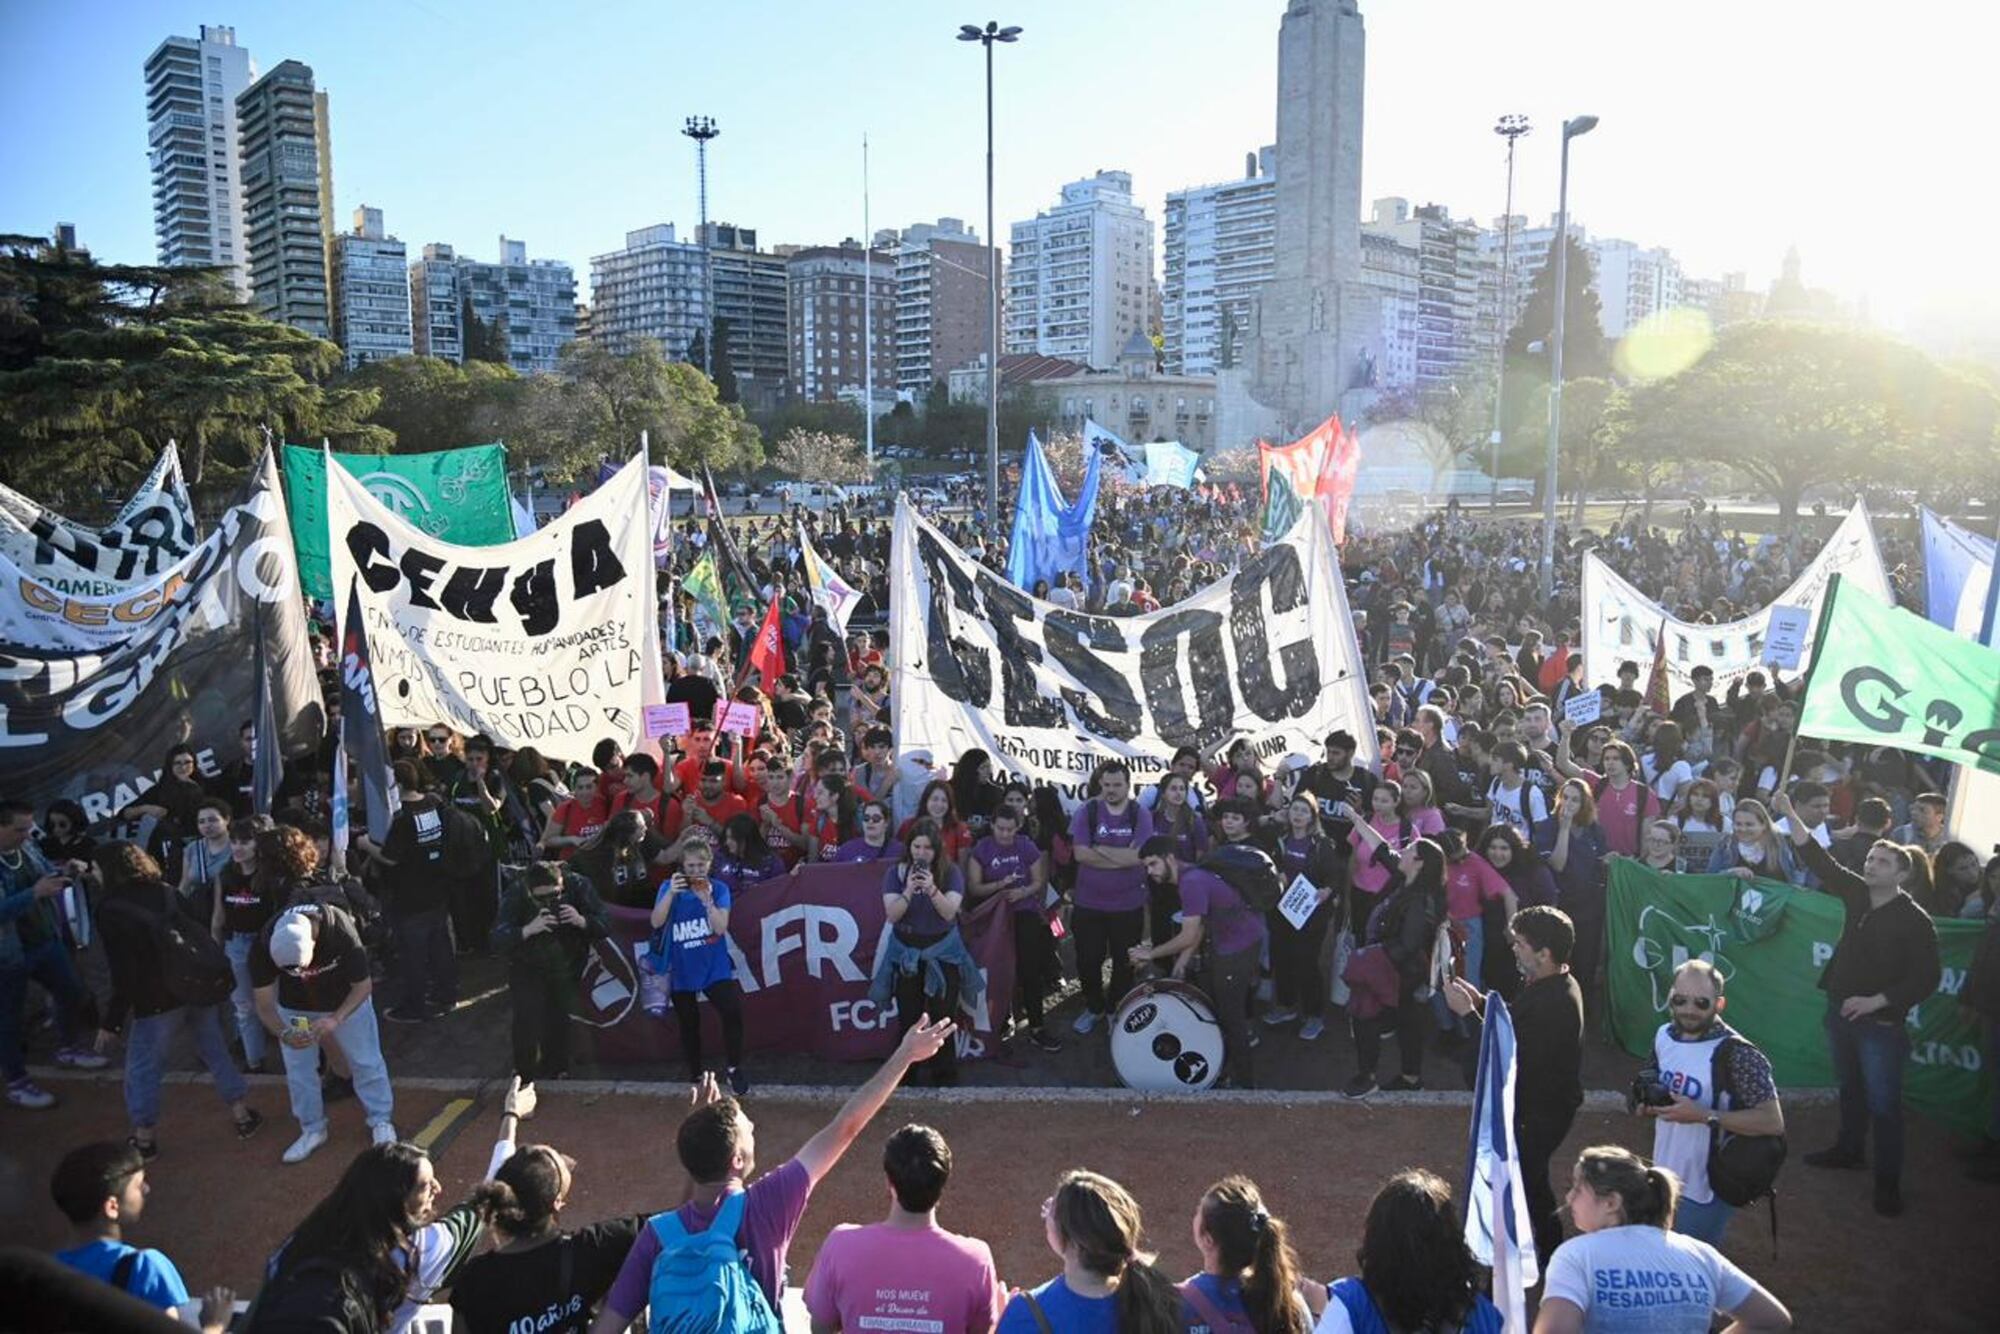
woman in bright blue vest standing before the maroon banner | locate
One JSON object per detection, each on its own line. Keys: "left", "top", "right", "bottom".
{"left": 648, "top": 840, "right": 750, "bottom": 1098}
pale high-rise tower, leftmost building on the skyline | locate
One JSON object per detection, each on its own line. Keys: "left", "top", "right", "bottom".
{"left": 146, "top": 24, "right": 256, "bottom": 296}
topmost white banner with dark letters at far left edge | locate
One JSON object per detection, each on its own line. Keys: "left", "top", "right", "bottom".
{"left": 0, "top": 442, "right": 198, "bottom": 598}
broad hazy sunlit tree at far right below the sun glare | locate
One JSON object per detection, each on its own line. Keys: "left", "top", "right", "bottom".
{"left": 1616, "top": 320, "right": 2000, "bottom": 518}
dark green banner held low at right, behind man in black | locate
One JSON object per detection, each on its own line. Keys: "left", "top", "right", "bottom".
{"left": 1606, "top": 856, "right": 1992, "bottom": 1134}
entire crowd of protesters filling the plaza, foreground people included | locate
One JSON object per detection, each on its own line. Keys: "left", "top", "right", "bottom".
{"left": 0, "top": 488, "right": 2000, "bottom": 1334}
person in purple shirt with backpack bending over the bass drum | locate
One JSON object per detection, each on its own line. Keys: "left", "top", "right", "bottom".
{"left": 1130, "top": 834, "right": 1266, "bottom": 1088}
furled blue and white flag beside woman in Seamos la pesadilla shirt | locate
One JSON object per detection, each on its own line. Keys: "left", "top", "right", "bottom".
{"left": 1464, "top": 992, "right": 1540, "bottom": 1334}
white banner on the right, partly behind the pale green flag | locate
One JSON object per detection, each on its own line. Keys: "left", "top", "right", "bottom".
{"left": 1582, "top": 504, "right": 1892, "bottom": 700}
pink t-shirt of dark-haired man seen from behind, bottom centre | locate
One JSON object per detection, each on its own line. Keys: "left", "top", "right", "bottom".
{"left": 806, "top": 1222, "right": 1000, "bottom": 1334}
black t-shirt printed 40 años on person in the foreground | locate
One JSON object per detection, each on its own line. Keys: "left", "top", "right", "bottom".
{"left": 452, "top": 1214, "right": 646, "bottom": 1334}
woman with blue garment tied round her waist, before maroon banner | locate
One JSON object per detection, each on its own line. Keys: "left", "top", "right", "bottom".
{"left": 868, "top": 818, "right": 986, "bottom": 1088}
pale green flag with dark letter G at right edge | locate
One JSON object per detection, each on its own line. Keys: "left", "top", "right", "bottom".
{"left": 1798, "top": 576, "right": 2000, "bottom": 774}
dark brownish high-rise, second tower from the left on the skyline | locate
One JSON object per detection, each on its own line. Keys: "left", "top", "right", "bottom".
{"left": 236, "top": 60, "right": 332, "bottom": 338}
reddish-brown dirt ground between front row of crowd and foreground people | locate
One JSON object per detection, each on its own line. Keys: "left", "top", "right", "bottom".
{"left": 0, "top": 1080, "right": 2000, "bottom": 1330}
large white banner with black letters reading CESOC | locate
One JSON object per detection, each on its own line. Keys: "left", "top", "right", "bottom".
{"left": 890, "top": 500, "right": 1376, "bottom": 800}
